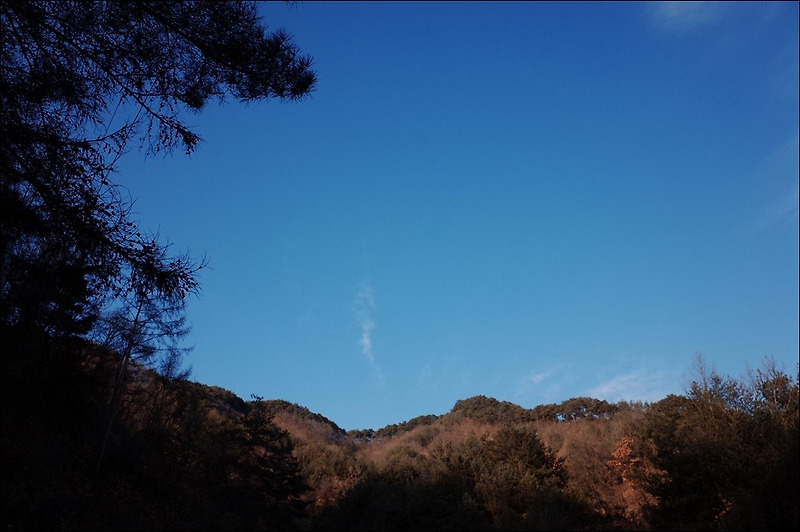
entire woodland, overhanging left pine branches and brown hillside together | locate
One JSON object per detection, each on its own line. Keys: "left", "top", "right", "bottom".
{"left": 0, "top": 0, "right": 800, "bottom": 530}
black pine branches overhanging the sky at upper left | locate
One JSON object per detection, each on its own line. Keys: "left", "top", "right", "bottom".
{"left": 0, "top": 0, "right": 316, "bottom": 342}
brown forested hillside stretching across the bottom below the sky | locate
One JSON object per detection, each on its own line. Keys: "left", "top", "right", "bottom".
{"left": 2, "top": 330, "right": 800, "bottom": 530}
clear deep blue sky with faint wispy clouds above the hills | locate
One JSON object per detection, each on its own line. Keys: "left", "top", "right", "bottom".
{"left": 119, "top": 1, "right": 798, "bottom": 430}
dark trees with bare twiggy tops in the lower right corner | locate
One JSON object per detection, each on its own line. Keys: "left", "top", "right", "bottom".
{"left": 635, "top": 359, "right": 799, "bottom": 530}
